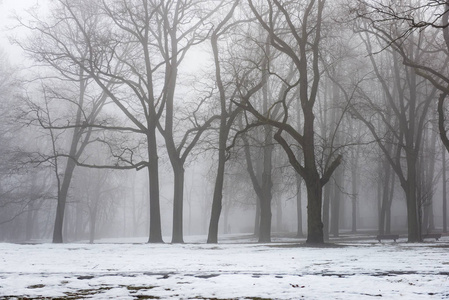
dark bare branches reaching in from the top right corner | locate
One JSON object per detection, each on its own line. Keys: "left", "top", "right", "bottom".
{"left": 350, "top": 0, "right": 449, "bottom": 156}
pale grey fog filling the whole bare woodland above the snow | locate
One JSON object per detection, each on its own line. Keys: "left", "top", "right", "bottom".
{"left": 0, "top": 0, "right": 449, "bottom": 244}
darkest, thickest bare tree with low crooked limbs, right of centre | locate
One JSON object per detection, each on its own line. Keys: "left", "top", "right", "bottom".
{"left": 244, "top": 0, "right": 341, "bottom": 243}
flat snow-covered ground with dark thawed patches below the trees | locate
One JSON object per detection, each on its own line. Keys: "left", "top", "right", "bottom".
{"left": 0, "top": 237, "right": 449, "bottom": 299}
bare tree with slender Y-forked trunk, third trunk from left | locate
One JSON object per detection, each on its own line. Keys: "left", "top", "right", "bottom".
{"left": 150, "top": 0, "right": 222, "bottom": 243}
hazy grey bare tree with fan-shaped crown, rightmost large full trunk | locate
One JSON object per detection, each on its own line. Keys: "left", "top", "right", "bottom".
{"left": 354, "top": 27, "right": 436, "bottom": 242}
